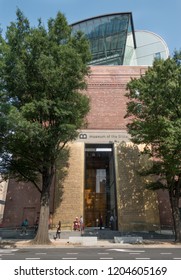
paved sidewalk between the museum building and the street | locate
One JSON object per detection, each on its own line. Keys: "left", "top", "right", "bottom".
{"left": 0, "top": 228, "right": 181, "bottom": 248}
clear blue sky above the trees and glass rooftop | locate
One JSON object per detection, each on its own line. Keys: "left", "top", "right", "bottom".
{"left": 0, "top": 0, "right": 181, "bottom": 55}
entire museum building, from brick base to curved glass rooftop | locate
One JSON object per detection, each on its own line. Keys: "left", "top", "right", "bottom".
{"left": 0, "top": 13, "right": 175, "bottom": 231}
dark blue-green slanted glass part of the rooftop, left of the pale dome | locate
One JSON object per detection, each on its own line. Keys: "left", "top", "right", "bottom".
{"left": 72, "top": 13, "right": 136, "bottom": 65}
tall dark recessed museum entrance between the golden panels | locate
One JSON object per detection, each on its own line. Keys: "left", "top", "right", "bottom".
{"left": 84, "top": 144, "right": 117, "bottom": 229}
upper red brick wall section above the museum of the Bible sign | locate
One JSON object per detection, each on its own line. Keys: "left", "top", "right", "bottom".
{"left": 86, "top": 66, "right": 146, "bottom": 130}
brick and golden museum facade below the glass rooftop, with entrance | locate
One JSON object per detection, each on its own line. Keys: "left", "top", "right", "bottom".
{"left": 3, "top": 66, "right": 172, "bottom": 231}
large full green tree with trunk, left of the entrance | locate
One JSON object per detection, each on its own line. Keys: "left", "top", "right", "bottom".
{"left": 0, "top": 9, "right": 90, "bottom": 244}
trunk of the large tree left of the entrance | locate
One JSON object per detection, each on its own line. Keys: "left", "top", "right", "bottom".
{"left": 32, "top": 167, "right": 54, "bottom": 245}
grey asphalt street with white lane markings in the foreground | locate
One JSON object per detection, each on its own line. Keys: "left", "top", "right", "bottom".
{"left": 0, "top": 246, "right": 181, "bottom": 260}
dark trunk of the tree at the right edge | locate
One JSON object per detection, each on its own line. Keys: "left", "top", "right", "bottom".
{"left": 169, "top": 191, "right": 181, "bottom": 242}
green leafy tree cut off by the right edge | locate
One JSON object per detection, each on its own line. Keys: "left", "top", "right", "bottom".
{"left": 125, "top": 51, "right": 181, "bottom": 241}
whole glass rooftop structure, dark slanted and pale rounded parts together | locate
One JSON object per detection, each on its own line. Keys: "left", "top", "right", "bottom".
{"left": 71, "top": 12, "right": 169, "bottom": 66}
